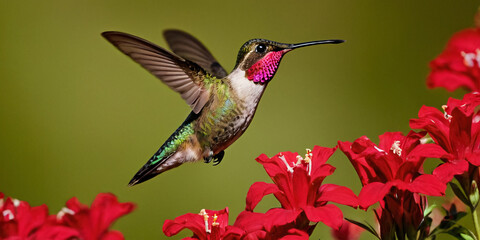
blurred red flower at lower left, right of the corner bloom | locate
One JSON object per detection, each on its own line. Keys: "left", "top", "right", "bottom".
{"left": 41, "top": 193, "right": 135, "bottom": 240}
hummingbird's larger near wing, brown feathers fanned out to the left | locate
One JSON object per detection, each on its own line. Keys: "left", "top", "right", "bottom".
{"left": 102, "top": 32, "right": 210, "bottom": 113}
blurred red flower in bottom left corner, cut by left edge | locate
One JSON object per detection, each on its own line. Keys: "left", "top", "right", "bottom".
{"left": 0, "top": 193, "right": 48, "bottom": 239}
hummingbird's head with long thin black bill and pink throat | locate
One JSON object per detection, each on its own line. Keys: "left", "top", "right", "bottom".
{"left": 235, "top": 39, "right": 344, "bottom": 84}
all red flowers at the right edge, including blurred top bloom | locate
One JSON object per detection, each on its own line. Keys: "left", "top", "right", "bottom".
{"left": 328, "top": 10, "right": 480, "bottom": 239}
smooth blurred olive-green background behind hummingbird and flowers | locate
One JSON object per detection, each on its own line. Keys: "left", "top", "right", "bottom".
{"left": 0, "top": 0, "right": 478, "bottom": 239}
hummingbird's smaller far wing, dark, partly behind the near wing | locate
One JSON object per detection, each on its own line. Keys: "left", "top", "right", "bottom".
{"left": 163, "top": 29, "right": 227, "bottom": 78}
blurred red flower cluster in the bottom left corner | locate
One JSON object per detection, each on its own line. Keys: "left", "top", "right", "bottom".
{"left": 0, "top": 193, "right": 134, "bottom": 240}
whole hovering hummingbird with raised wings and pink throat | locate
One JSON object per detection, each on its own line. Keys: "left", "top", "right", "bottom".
{"left": 102, "top": 30, "right": 344, "bottom": 186}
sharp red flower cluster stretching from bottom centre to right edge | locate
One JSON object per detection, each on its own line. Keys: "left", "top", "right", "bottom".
{"left": 163, "top": 93, "right": 480, "bottom": 240}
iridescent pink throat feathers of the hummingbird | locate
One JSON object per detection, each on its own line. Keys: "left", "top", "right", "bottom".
{"left": 247, "top": 51, "right": 285, "bottom": 83}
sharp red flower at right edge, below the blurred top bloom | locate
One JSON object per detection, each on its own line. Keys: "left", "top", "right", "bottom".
{"left": 410, "top": 93, "right": 480, "bottom": 204}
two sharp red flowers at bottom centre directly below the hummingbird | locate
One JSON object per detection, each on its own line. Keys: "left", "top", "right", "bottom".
{"left": 163, "top": 146, "right": 358, "bottom": 239}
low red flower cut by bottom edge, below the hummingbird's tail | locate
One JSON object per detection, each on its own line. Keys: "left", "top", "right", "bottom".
{"left": 163, "top": 208, "right": 233, "bottom": 240}
